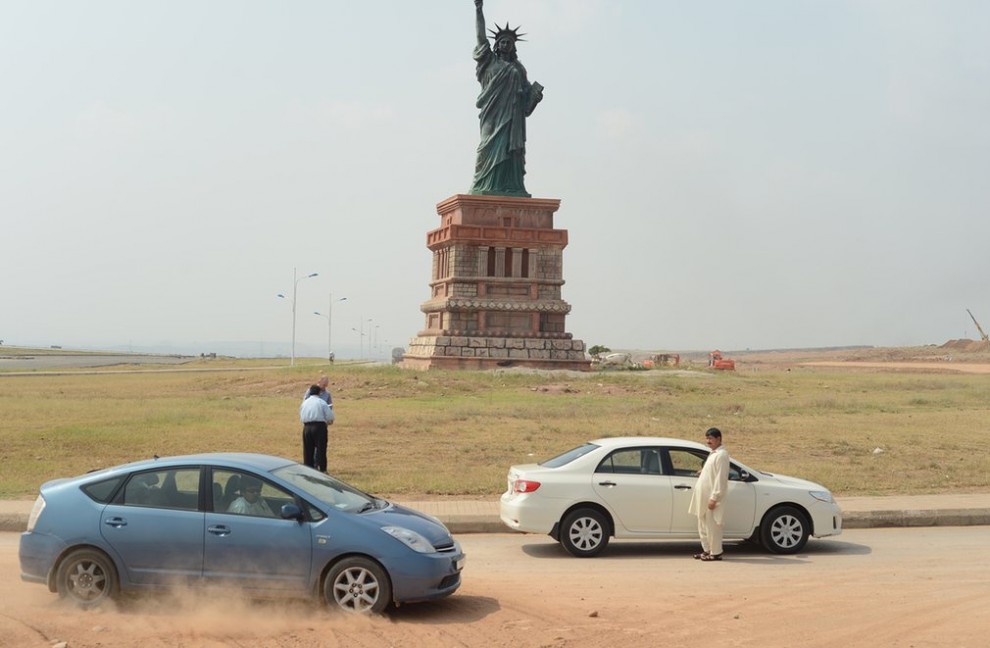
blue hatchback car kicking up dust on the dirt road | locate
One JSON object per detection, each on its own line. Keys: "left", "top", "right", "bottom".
{"left": 19, "top": 453, "right": 464, "bottom": 613}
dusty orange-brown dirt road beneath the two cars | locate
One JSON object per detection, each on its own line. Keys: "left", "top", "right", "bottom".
{"left": 0, "top": 527, "right": 990, "bottom": 648}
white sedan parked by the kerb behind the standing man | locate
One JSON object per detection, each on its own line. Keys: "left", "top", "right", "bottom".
{"left": 500, "top": 437, "right": 842, "bottom": 558}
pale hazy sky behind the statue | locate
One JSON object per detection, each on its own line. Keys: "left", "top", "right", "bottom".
{"left": 0, "top": 0, "right": 990, "bottom": 356}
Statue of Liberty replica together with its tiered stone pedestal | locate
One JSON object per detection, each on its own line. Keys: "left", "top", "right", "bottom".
{"left": 399, "top": 0, "right": 591, "bottom": 371}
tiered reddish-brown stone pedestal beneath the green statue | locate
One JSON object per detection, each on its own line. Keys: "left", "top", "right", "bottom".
{"left": 402, "top": 194, "right": 591, "bottom": 371}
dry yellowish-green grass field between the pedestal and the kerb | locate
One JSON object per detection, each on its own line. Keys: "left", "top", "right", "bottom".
{"left": 0, "top": 360, "right": 990, "bottom": 498}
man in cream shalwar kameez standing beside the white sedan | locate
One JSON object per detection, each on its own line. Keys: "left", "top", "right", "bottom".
{"left": 688, "top": 428, "right": 729, "bottom": 562}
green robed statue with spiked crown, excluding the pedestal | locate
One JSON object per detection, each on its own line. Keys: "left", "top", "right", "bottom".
{"left": 471, "top": 0, "right": 543, "bottom": 198}
